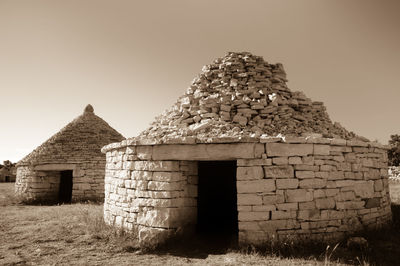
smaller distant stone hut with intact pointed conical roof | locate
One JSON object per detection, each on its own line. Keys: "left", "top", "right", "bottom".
{"left": 15, "top": 105, "right": 124, "bottom": 203}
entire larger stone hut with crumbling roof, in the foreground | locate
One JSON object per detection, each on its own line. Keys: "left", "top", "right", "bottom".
{"left": 102, "top": 53, "right": 391, "bottom": 245}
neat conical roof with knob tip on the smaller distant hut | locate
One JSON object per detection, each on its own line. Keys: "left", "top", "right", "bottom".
{"left": 18, "top": 104, "right": 125, "bottom": 165}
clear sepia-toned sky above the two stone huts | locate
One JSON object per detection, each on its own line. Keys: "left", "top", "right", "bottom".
{"left": 0, "top": 0, "right": 400, "bottom": 162}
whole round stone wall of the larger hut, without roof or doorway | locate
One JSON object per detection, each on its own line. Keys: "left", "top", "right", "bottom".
{"left": 103, "top": 137, "right": 391, "bottom": 245}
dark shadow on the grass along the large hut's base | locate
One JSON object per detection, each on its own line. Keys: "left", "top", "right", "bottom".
{"left": 144, "top": 204, "right": 400, "bottom": 265}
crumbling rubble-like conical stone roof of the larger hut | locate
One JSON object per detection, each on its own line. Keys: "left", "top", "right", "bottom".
{"left": 139, "top": 52, "right": 356, "bottom": 142}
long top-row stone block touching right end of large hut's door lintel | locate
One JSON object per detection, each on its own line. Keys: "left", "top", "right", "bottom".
{"left": 265, "top": 143, "right": 313, "bottom": 157}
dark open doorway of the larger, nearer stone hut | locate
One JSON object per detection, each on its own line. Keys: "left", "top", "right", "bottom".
{"left": 197, "top": 161, "right": 238, "bottom": 244}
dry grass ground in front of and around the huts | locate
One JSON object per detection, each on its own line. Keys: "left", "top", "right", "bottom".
{"left": 0, "top": 183, "right": 400, "bottom": 265}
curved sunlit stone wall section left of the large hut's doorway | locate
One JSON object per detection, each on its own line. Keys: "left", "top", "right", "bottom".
{"left": 104, "top": 146, "right": 197, "bottom": 245}
